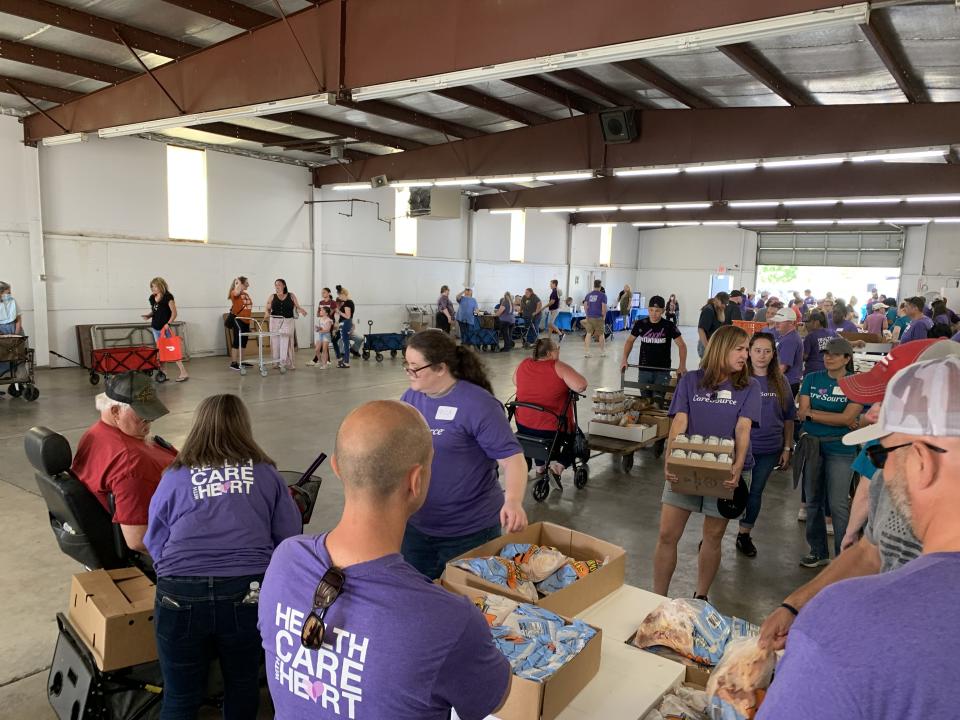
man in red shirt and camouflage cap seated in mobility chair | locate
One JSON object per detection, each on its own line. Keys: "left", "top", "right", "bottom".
{"left": 72, "top": 372, "right": 177, "bottom": 552}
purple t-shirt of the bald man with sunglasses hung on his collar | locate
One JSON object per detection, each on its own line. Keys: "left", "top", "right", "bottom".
{"left": 258, "top": 534, "right": 510, "bottom": 720}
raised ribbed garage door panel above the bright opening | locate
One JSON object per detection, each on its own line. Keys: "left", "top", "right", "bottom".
{"left": 757, "top": 230, "right": 904, "bottom": 268}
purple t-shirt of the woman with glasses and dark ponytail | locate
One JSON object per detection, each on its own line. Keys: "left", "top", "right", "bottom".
{"left": 400, "top": 380, "right": 523, "bottom": 537}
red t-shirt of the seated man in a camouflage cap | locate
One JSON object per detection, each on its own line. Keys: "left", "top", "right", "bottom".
{"left": 73, "top": 420, "right": 177, "bottom": 525}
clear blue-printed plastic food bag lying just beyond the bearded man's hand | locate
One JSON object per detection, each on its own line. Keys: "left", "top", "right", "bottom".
{"left": 632, "top": 598, "right": 730, "bottom": 665}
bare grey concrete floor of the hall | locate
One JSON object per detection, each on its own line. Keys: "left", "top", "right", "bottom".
{"left": 0, "top": 332, "right": 811, "bottom": 720}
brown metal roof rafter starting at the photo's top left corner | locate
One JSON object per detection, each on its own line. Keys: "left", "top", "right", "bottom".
{"left": 0, "top": 0, "right": 199, "bottom": 58}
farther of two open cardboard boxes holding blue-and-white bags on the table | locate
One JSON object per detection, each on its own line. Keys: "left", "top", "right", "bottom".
{"left": 443, "top": 522, "right": 627, "bottom": 617}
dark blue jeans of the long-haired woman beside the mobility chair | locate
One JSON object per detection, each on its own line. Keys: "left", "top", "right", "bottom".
{"left": 154, "top": 575, "right": 263, "bottom": 720}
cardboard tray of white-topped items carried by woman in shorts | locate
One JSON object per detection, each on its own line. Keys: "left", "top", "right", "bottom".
{"left": 667, "top": 433, "right": 735, "bottom": 500}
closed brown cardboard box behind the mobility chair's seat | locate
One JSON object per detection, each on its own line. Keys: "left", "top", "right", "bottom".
{"left": 67, "top": 568, "right": 157, "bottom": 670}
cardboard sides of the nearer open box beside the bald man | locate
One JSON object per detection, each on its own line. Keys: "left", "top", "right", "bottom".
{"left": 442, "top": 580, "right": 603, "bottom": 720}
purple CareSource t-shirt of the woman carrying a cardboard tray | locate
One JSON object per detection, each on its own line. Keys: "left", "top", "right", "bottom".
{"left": 669, "top": 370, "right": 761, "bottom": 470}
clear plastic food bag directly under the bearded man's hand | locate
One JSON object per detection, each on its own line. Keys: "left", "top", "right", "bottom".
{"left": 707, "top": 638, "right": 777, "bottom": 720}
